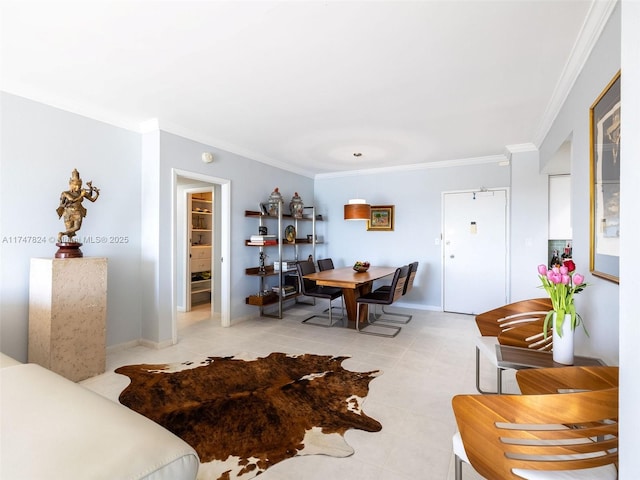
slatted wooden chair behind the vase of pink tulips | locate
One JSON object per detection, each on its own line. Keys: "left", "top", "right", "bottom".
{"left": 475, "top": 297, "right": 553, "bottom": 393}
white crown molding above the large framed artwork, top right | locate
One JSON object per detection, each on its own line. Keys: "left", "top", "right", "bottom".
{"left": 534, "top": 0, "right": 619, "bottom": 146}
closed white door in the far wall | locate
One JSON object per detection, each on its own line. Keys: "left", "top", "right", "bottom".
{"left": 442, "top": 190, "right": 508, "bottom": 314}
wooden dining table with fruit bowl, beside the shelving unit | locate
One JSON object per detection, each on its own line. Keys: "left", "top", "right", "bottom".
{"left": 304, "top": 267, "right": 396, "bottom": 322}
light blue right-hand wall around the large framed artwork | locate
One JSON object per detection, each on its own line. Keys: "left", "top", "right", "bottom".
{"left": 540, "top": 1, "right": 624, "bottom": 364}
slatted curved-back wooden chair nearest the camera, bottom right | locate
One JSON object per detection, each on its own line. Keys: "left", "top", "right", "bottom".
{"left": 452, "top": 387, "right": 618, "bottom": 480}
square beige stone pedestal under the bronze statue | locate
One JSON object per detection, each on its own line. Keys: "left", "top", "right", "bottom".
{"left": 29, "top": 257, "right": 107, "bottom": 382}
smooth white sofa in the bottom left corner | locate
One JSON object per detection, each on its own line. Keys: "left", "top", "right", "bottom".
{"left": 0, "top": 353, "right": 200, "bottom": 480}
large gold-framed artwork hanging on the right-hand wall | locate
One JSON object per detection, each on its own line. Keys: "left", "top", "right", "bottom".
{"left": 589, "top": 72, "right": 621, "bottom": 283}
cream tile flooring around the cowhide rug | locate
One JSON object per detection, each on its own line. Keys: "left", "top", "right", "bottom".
{"left": 82, "top": 304, "right": 515, "bottom": 480}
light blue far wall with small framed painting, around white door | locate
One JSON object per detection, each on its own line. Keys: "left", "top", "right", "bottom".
{"left": 316, "top": 161, "right": 509, "bottom": 310}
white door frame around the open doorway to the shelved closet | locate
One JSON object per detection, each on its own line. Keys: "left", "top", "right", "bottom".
{"left": 171, "top": 169, "right": 231, "bottom": 343}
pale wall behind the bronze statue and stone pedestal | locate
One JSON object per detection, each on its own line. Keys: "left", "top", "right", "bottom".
{"left": 0, "top": 93, "right": 141, "bottom": 361}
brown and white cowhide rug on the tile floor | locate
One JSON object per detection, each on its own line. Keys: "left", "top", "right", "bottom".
{"left": 116, "top": 353, "right": 382, "bottom": 480}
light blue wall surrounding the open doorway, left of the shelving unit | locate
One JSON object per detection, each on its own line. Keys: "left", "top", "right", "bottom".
{"left": 142, "top": 132, "right": 313, "bottom": 342}
